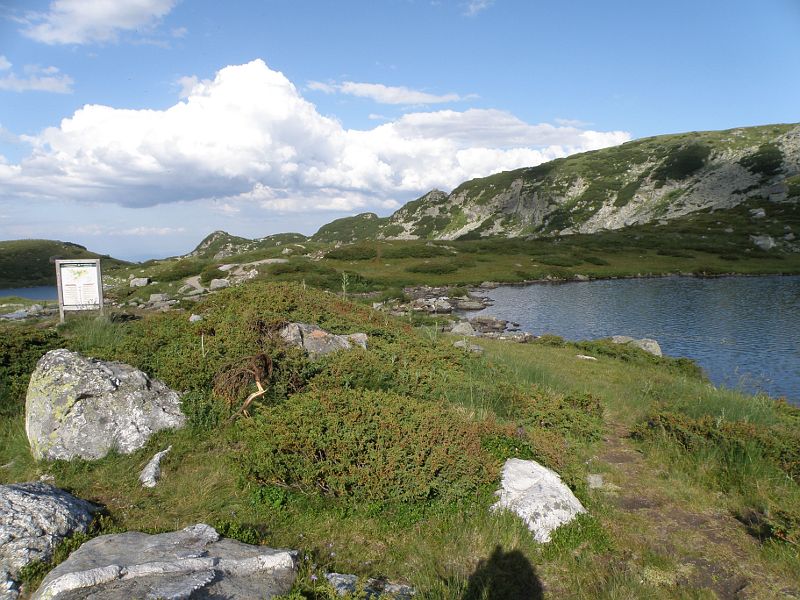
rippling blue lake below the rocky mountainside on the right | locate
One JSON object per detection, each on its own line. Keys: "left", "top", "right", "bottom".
{"left": 474, "top": 276, "right": 800, "bottom": 404}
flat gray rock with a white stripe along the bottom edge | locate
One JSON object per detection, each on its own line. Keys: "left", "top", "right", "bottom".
{"left": 33, "top": 523, "right": 297, "bottom": 600}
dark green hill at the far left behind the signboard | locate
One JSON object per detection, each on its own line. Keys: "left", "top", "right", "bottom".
{"left": 0, "top": 240, "right": 125, "bottom": 287}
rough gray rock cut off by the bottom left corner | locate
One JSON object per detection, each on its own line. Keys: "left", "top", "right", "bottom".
{"left": 0, "top": 481, "right": 99, "bottom": 598}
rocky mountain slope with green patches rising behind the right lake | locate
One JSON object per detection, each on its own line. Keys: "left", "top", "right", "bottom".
{"left": 312, "top": 124, "right": 800, "bottom": 242}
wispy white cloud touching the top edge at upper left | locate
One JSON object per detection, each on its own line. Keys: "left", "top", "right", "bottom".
{"left": 22, "top": 0, "right": 177, "bottom": 45}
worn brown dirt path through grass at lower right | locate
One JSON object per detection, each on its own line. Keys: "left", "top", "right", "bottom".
{"left": 591, "top": 425, "right": 800, "bottom": 599}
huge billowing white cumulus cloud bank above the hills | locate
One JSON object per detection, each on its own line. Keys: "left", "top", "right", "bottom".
{"left": 0, "top": 60, "right": 630, "bottom": 214}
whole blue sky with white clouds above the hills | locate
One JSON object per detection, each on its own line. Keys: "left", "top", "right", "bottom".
{"left": 0, "top": 0, "right": 800, "bottom": 260}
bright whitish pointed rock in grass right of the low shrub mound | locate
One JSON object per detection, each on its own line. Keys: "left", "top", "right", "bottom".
{"left": 492, "top": 458, "right": 586, "bottom": 543}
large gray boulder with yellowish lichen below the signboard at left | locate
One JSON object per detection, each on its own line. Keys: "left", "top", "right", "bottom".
{"left": 25, "top": 349, "right": 186, "bottom": 460}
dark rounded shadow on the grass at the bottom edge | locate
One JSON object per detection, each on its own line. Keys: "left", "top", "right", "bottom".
{"left": 462, "top": 545, "right": 544, "bottom": 600}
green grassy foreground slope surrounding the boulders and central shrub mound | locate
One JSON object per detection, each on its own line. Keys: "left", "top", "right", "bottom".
{"left": 0, "top": 284, "right": 800, "bottom": 598}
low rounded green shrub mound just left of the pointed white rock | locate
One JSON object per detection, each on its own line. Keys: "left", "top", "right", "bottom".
{"left": 237, "top": 390, "right": 497, "bottom": 502}
